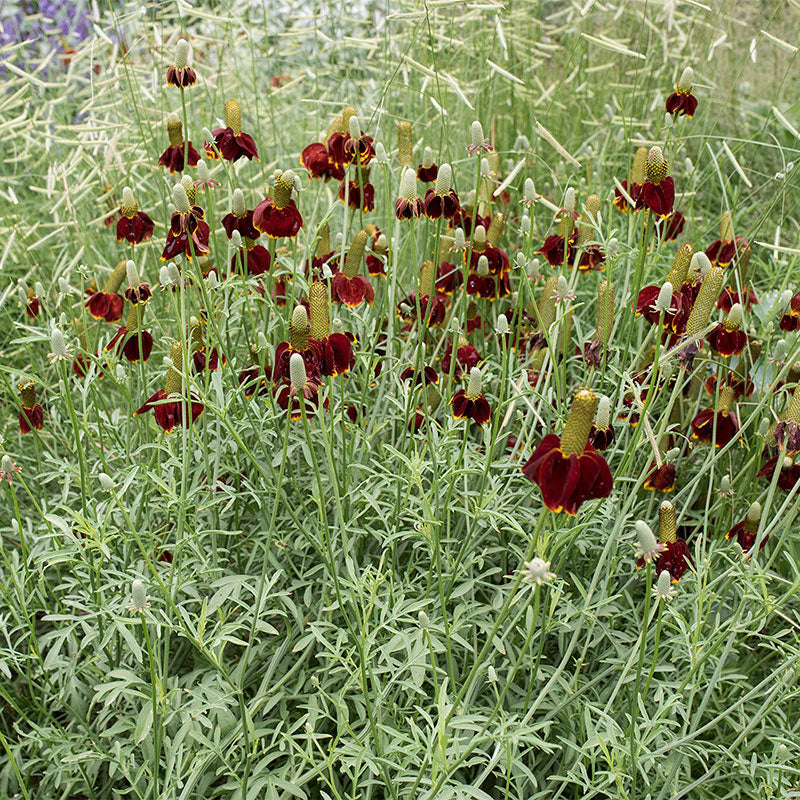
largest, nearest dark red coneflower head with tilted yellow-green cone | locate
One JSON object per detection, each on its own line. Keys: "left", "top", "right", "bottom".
{"left": 522, "top": 389, "right": 614, "bottom": 514}
